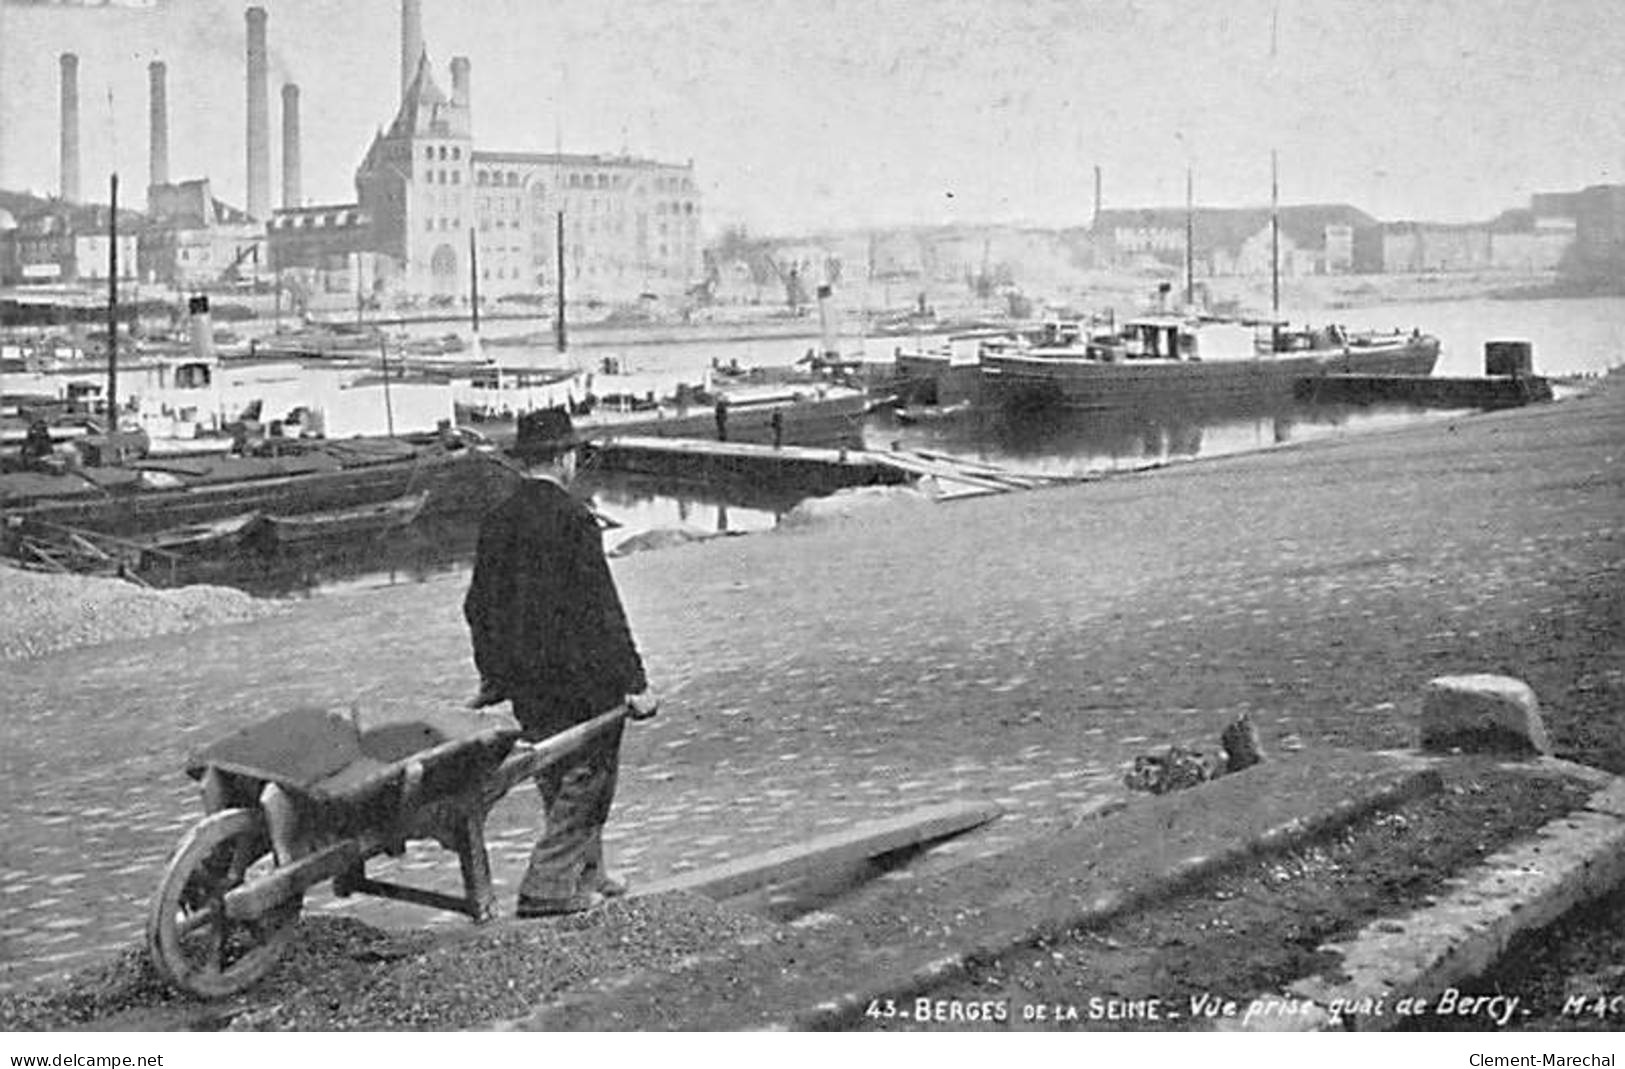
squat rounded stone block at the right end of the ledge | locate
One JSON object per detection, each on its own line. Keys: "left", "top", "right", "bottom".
{"left": 1422, "top": 674, "right": 1552, "bottom": 754}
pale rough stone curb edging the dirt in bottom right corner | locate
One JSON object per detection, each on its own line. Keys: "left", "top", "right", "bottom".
{"left": 1216, "top": 759, "right": 1625, "bottom": 1032}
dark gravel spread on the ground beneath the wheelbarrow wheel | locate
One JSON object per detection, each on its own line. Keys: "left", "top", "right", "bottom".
{"left": 0, "top": 894, "right": 772, "bottom": 1032}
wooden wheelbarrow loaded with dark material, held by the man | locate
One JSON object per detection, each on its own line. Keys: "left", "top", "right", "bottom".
{"left": 146, "top": 702, "right": 655, "bottom": 998}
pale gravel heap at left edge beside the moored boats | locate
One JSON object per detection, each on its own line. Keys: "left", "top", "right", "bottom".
{"left": 0, "top": 564, "right": 283, "bottom": 661}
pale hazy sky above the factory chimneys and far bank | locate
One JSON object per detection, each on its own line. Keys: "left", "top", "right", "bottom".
{"left": 0, "top": 0, "right": 1625, "bottom": 234}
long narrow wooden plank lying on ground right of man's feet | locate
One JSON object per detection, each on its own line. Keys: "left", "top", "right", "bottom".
{"left": 634, "top": 801, "right": 1003, "bottom": 898}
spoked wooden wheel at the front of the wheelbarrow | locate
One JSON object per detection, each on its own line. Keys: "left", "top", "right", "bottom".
{"left": 146, "top": 809, "right": 302, "bottom": 998}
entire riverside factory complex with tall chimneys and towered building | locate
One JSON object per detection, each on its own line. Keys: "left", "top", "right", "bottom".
{"left": 0, "top": 0, "right": 704, "bottom": 307}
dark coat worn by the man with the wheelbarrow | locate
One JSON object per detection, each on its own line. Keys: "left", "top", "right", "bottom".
{"left": 463, "top": 479, "right": 647, "bottom": 720}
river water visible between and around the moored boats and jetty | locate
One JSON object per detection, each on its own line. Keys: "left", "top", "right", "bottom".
{"left": 196, "top": 297, "right": 1625, "bottom": 596}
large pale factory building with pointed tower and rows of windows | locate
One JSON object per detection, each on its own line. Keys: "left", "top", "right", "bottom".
{"left": 268, "top": 0, "right": 704, "bottom": 304}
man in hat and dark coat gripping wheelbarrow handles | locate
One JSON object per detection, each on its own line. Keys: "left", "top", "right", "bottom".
{"left": 463, "top": 409, "right": 648, "bottom": 918}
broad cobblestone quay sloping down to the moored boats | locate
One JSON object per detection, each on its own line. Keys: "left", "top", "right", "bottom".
{"left": 0, "top": 377, "right": 1625, "bottom": 986}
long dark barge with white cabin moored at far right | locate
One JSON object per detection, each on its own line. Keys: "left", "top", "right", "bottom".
{"left": 982, "top": 315, "right": 1440, "bottom": 409}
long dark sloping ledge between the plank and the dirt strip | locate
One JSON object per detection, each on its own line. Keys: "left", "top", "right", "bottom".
{"left": 492, "top": 752, "right": 1443, "bottom": 1030}
